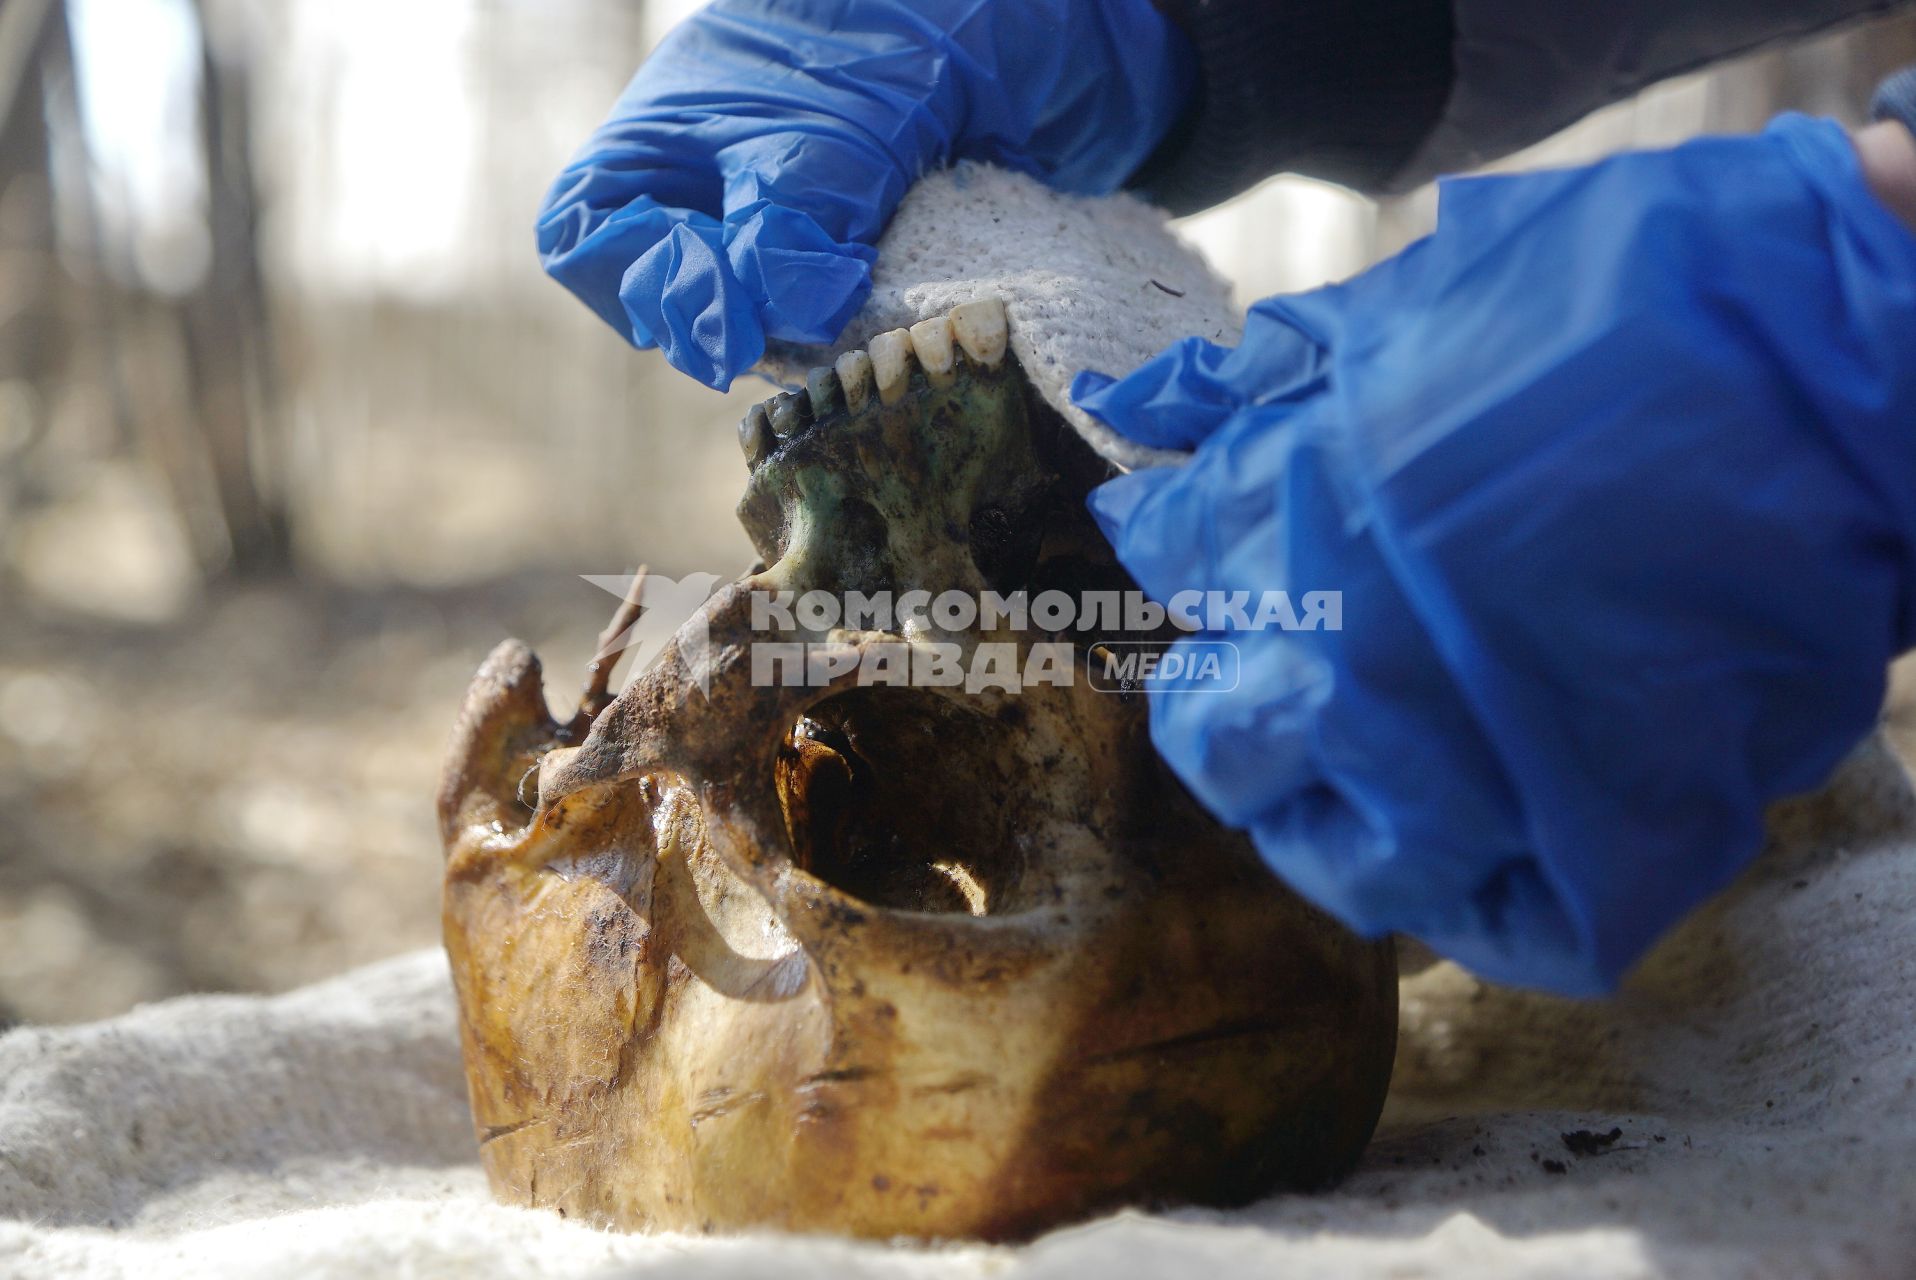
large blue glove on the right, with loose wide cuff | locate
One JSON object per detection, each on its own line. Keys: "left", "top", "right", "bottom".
{"left": 1073, "top": 117, "right": 1916, "bottom": 994}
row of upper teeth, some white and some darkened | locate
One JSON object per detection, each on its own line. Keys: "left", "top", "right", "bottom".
{"left": 738, "top": 297, "right": 1008, "bottom": 466}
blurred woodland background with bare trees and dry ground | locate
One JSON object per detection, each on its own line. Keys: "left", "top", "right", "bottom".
{"left": 0, "top": 0, "right": 1916, "bottom": 1025}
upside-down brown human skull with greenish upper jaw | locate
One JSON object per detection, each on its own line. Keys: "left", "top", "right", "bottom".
{"left": 439, "top": 301, "right": 1397, "bottom": 1240}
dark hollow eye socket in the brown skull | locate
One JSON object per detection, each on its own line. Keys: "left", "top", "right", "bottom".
{"left": 774, "top": 690, "right": 1023, "bottom": 916}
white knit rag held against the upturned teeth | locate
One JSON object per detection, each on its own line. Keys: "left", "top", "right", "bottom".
{"left": 761, "top": 165, "right": 1243, "bottom": 469}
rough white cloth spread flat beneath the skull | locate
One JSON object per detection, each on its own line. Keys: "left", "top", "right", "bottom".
{"left": 0, "top": 728, "right": 1916, "bottom": 1280}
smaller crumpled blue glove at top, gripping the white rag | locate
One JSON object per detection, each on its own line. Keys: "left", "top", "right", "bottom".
{"left": 538, "top": 0, "right": 1192, "bottom": 389}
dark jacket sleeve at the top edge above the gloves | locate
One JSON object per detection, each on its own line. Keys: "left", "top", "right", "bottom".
{"left": 1134, "top": 0, "right": 1912, "bottom": 213}
